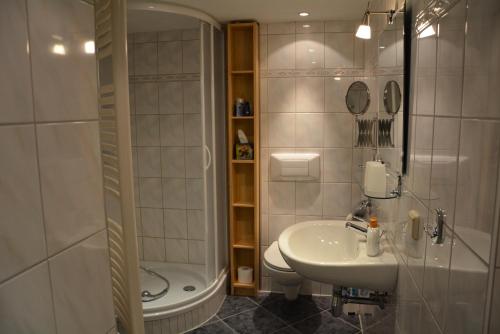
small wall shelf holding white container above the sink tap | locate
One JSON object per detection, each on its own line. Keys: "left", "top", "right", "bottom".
{"left": 359, "top": 160, "right": 402, "bottom": 199}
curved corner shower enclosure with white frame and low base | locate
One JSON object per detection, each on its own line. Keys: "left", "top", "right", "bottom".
{"left": 127, "top": 2, "right": 227, "bottom": 333}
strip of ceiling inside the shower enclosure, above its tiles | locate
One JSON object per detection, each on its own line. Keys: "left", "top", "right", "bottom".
{"left": 127, "top": 9, "right": 200, "bottom": 33}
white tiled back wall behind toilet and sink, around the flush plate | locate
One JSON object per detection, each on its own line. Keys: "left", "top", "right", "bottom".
{"left": 260, "top": 21, "right": 403, "bottom": 294}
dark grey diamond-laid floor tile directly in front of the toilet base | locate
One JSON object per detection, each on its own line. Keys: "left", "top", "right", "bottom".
{"left": 262, "top": 296, "right": 323, "bottom": 324}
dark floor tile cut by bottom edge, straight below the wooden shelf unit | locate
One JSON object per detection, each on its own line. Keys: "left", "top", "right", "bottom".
{"left": 224, "top": 307, "right": 286, "bottom": 334}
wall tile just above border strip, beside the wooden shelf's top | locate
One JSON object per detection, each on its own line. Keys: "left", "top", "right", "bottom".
{"left": 267, "top": 35, "right": 295, "bottom": 70}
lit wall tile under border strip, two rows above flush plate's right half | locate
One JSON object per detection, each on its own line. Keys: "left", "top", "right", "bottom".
{"left": 296, "top": 77, "right": 325, "bottom": 113}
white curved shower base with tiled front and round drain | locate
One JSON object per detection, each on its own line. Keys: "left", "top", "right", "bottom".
{"left": 140, "top": 262, "right": 227, "bottom": 334}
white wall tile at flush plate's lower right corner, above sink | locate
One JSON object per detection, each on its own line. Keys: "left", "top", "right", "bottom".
{"left": 323, "top": 183, "right": 351, "bottom": 217}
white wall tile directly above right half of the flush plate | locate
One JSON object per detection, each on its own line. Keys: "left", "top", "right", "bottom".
{"left": 296, "top": 114, "right": 323, "bottom": 147}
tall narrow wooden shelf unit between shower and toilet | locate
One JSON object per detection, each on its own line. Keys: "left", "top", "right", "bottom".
{"left": 227, "top": 22, "right": 260, "bottom": 296}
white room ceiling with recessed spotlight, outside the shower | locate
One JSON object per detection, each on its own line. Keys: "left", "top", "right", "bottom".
{"left": 129, "top": 0, "right": 370, "bottom": 23}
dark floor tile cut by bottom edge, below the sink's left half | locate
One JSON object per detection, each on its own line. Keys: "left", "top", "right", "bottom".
{"left": 293, "top": 311, "right": 359, "bottom": 334}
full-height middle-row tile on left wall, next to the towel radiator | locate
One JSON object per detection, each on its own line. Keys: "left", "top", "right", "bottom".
{"left": 37, "top": 122, "right": 105, "bottom": 254}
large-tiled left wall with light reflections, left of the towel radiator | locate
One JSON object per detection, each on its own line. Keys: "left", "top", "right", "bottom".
{"left": 0, "top": 0, "right": 114, "bottom": 334}
